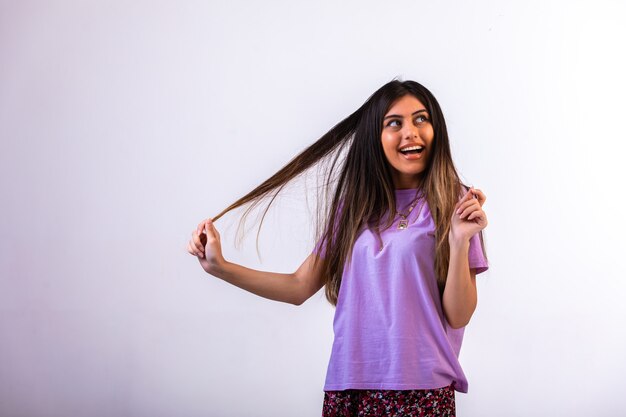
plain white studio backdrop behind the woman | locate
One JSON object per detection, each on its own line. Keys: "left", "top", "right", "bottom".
{"left": 0, "top": 0, "right": 626, "bottom": 417}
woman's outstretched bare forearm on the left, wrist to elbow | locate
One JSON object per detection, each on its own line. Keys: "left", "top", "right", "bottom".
{"left": 212, "top": 261, "right": 301, "bottom": 305}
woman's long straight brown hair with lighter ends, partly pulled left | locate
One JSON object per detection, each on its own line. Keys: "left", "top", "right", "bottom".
{"left": 213, "top": 79, "right": 486, "bottom": 305}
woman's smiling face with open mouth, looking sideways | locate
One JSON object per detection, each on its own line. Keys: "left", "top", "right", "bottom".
{"left": 380, "top": 95, "right": 435, "bottom": 189}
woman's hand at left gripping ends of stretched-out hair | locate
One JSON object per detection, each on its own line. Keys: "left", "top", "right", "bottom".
{"left": 187, "top": 219, "right": 225, "bottom": 275}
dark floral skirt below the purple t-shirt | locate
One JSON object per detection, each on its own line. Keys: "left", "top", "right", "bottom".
{"left": 322, "top": 383, "right": 456, "bottom": 417}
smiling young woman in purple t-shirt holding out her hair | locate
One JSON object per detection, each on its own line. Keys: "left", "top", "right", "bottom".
{"left": 187, "top": 80, "right": 488, "bottom": 417}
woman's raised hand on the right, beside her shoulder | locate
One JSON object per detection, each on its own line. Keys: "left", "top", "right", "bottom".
{"left": 448, "top": 187, "right": 487, "bottom": 242}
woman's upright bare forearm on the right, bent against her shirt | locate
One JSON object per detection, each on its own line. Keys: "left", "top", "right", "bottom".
{"left": 443, "top": 240, "right": 477, "bottom": 328}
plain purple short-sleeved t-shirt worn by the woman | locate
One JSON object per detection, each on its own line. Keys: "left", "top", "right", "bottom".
{"left": 314, "top": 189, "right": 488, "bottom": 392}
